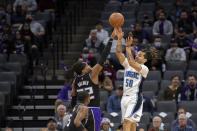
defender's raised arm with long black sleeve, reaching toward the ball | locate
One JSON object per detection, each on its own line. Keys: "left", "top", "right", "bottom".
{"left": 91, "top": 31, "right": 115, "bottom": 84}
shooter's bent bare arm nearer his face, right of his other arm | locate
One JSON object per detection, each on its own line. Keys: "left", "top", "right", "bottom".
{"left": 126, "top": 37, "right": 142, "bottom": 72}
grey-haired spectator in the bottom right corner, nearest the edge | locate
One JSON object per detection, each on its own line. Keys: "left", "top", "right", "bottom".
{"left": 171, "top": 114, "right": 195, "bottom": 131}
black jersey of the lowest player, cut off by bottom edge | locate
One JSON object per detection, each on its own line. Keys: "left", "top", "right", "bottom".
{"left": 64, "top": 104, "right": 88, "bottom": 131}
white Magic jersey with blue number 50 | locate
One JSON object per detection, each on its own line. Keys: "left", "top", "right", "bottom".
{"left": 122, "top": 58, "right": 149, "bottom": 95}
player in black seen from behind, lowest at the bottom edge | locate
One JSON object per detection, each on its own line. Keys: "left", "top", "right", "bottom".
{"left": 64, "top": 91, "right": 90, "bottom": 131}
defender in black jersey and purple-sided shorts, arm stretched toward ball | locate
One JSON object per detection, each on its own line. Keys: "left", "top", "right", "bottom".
{"left": 72, "top": 28, "right": 119, "bottom": 131}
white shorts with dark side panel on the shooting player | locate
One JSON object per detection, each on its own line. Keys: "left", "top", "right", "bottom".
{"left": 121, "top": 95, "right": 143, "bottom": 122}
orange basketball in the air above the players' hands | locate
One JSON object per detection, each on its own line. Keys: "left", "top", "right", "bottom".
{"left": 109, "top": 13, "right": 124, "bottom": 27}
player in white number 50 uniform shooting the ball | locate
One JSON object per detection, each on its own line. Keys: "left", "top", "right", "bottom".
{"left": 115, "top": 28, "right": 155, "bottom": 131}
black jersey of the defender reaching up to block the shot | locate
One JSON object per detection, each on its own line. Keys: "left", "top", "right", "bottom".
{"left": 74, "top": 73, "right": 100, "bottom": 107}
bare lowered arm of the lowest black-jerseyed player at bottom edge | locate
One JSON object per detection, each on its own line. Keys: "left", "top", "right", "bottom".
{"left": 74, "top": 106, "right": 88, "bottom": 130}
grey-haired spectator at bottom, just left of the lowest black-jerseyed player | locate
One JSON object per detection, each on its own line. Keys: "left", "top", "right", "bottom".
{"left": 55, "top": 105, "right": 66, "bottom": 131}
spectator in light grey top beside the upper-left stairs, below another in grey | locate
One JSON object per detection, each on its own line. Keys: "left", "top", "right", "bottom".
{"left": 26, "top": 13, "right": 45, "bottom": 38}
